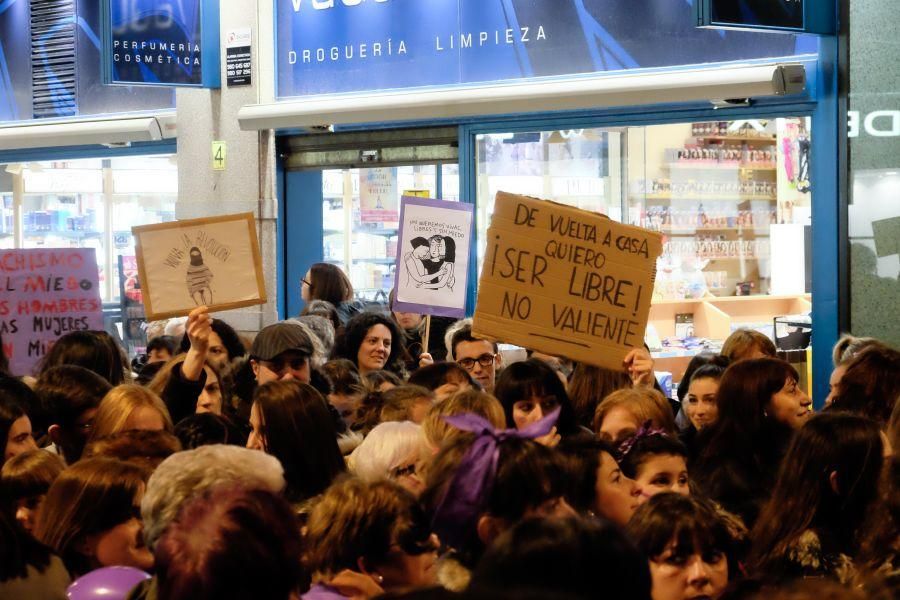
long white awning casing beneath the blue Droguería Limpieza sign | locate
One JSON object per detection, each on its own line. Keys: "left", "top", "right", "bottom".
{"left": 238, "top": 63, "right": 806, "bottom": 130}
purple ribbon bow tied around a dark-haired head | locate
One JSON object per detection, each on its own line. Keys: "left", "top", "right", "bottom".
{"left": 432, "top": 407, "right": 560, "bottom": 548}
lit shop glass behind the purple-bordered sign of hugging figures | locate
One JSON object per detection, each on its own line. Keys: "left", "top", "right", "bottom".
{"left": 322, "top": 164, "right": 459, "bottom": 302}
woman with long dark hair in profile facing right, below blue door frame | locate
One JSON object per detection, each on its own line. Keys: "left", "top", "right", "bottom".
{"left": 691, "top": 358, "right": 812, "bottom": 527}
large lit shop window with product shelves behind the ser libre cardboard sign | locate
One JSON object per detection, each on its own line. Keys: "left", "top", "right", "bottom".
{"left": 477, "top": 118, "right": 811, "bottom": 381}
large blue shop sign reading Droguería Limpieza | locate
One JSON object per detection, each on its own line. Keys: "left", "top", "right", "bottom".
{"left": 275, "top": 0, "right": 816, "bottom": 98}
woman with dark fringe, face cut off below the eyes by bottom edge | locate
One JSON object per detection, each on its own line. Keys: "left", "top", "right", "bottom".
{"left": 627, "top": 493, "right": 738, "bottom": 600}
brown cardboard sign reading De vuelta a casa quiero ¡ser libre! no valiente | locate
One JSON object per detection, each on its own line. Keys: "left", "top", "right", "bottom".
{"left": 472, "top": 192, "right": 662, "bottom": 370}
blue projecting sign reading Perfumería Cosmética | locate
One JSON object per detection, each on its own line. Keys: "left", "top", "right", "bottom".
{"left": 102, "top": 0, "right": 220, "bottom": 87}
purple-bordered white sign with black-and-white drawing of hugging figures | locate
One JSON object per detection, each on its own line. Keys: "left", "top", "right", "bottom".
{"left": 392, "top": 196, "right": 474, "bottom": 319}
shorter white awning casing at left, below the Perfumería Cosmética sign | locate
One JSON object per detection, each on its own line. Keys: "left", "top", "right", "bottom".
{"left": 0, "top": 114, "right": 174, "bottom": 150}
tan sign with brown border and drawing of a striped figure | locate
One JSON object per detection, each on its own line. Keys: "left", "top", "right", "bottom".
{"left": 131, "top": 213, "right": 266, "bottom": 321}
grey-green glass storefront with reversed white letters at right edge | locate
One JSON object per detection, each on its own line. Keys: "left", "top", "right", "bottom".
{"left": 848, "top": 0, "right": 900, "bottom": 346}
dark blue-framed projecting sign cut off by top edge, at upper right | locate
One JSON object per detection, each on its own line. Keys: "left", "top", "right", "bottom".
{"left": 695, "top": 0, "right": 835, "bottom": 34}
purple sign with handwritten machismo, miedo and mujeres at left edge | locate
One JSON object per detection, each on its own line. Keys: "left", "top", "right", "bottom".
{"left": 0, "top": 248, "right": 103, "bottom": 375}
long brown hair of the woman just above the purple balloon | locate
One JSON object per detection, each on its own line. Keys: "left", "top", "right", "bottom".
{"left": 34, "top": 458, "right": 147, "bottom": 575}
